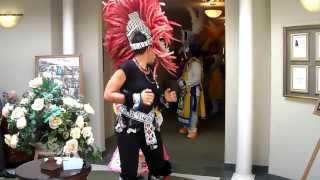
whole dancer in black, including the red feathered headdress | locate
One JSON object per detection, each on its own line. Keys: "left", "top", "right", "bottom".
{"left": 103, "top": 0, "right": 177, "bottom": 180}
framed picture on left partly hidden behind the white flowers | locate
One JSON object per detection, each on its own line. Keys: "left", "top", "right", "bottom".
{"left": 35, "top": 55, "right": 83, "bottom": 98}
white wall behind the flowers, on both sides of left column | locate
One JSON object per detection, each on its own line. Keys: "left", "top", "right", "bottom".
{"left": 0, "top": 0, "right": 105, "bottom": 150}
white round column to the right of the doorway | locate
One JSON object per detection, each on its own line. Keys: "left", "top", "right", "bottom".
{"left": 232, "top": 0, "right": 254, "bottom": 180}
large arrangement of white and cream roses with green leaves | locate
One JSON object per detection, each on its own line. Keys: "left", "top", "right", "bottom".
{"left": 2, "top": 77, "right": 101, "bottom": 161}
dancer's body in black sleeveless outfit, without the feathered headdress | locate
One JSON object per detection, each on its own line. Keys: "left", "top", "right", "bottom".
{"left": 105, "top": 32, "right": 177, "bottom": 180}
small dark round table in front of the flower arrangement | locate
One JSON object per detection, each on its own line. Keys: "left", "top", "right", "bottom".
{"left": 16, "top": 160, "right": 91, "bottom": 180}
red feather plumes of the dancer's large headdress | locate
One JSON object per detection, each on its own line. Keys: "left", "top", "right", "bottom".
{"left": 103, "top": 0, "right": 179, "bottom": 73}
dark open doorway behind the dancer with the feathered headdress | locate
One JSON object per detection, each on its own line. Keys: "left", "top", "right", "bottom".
{"left": 104, "top": 0, "right": 225, "bottom": 177}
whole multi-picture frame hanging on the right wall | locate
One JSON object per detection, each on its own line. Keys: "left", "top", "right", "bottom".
{"left": 283, "top": 24, "right": 320, "bottom": 100}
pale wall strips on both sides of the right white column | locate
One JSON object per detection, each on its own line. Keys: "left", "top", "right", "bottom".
{"left": 225, "top": 0, "right": 270, "bottom": 166}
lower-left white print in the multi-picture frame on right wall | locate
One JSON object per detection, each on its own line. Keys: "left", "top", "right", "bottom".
{"left": 290, "top": 65, "right": 308, "bottom": 93}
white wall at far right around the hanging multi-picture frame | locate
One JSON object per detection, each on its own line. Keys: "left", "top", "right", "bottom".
{"left": 269, "top": 0, "right": 320, "bottom": 180}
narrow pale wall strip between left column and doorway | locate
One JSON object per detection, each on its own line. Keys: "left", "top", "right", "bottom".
{"left": 75, "top": 0, "right": 105, "bottom": 150}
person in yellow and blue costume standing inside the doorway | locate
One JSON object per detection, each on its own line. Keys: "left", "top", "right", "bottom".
{"left": 177, "top": 45, "right": 206, "bottom": 139}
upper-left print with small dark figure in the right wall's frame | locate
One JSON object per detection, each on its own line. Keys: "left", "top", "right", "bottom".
{"left": 290, "top": 33, "right": 309, "bottom": 61}
